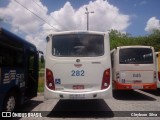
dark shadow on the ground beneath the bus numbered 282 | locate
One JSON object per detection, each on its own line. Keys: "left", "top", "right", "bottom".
{"left": 47, "top": 99, "right": 114, "bottom": 118}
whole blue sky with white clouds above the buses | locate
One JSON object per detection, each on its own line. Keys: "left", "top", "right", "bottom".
{"left": 0, "top": 0, "right": 160, "bottom": 51}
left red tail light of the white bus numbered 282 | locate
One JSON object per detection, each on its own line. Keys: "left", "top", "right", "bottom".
{"left": 46, "top": 69, "right": 55, "bottom": 90}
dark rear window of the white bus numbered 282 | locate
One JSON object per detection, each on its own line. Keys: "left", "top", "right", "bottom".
{"left": 52, "top": 34, "right": 104, "bottom": 57}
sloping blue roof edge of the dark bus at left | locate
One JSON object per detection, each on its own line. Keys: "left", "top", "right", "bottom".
{"left": 0, "top": 27, "right": 36, "bottom": 49}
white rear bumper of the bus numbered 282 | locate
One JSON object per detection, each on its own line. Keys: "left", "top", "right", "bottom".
{"left": 44, "top": 86, "right": 112, "bottom": 100}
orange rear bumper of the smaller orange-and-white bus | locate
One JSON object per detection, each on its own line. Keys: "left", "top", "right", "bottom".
{"left": 113, "top": 80, "right": 157, "bottom": 90}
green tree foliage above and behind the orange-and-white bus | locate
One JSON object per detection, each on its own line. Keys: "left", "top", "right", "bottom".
{"left": 109, "top": 30, "right": 160, "bottom": 51}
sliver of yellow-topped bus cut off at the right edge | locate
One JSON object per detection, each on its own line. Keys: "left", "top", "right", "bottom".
{"left": 156, "top": 52, "right": 160, "bottom": 88}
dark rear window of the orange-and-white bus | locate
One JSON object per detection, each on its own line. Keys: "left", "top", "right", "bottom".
{"left": 119, "top": 48, "right": 153, "bottom": 64}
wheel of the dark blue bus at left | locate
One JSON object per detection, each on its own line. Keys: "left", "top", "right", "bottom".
{"left": 4, "top": 92, "right": 17, "bottom": 111}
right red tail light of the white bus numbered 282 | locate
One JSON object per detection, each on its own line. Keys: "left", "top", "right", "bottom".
{"left": 101, "top": 69, "right": 110, "bottom": 90}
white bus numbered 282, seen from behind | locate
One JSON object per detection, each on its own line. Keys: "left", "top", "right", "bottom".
{"left": 44, "top": 31, "right": 112, "bottom": 99}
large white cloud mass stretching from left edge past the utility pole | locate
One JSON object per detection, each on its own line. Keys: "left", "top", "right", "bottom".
{"left": 0, "top": 0, "right": 130, "bottom": 50}
